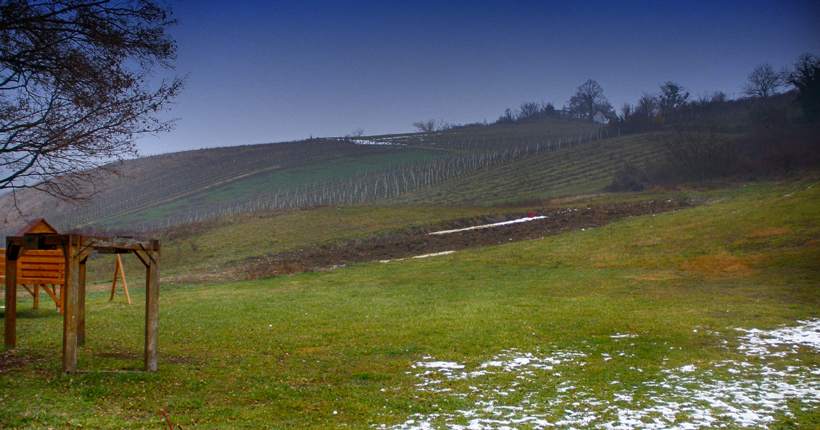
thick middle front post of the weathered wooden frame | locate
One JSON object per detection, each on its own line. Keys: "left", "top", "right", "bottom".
{"left": 63, "top": 234, "right": 80, "bottom": 373}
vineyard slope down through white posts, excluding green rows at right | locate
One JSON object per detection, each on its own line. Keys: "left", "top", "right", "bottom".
{"left": 1, "top": 121, "right": 609, "bottom": 234}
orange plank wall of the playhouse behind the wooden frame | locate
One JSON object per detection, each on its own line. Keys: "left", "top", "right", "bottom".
{"left": 0, "top": 249, "right": 65, "bottom": 313}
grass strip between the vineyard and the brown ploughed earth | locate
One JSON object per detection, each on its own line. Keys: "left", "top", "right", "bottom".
{"left": 83, "top": 205, "right": 524, "bottom": 282}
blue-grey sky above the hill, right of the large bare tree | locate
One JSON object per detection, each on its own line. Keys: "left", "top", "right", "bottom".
{"left": 138, "top": 0, "right": 820, "bottom": 155}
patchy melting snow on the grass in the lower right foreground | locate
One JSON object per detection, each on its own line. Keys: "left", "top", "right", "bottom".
{"left": 377, "top": 319, "right": 820, "bottom": 430}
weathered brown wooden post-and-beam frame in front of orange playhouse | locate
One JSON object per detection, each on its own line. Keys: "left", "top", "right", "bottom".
{"left": 3, "top": 218, "right": 160, "bottom": 373}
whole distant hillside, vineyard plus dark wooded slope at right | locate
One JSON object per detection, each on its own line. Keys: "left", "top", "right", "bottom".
{"left": 0, "top": 94, "right": 820, "bottom": 239}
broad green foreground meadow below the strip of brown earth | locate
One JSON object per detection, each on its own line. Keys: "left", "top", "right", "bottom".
{"left": 0, "top": 178, "right": 820, "bottom": 429}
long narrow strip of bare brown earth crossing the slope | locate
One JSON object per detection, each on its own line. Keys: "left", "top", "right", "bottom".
{"left": 239, "top": 199, "right": 695, "bottom": 279}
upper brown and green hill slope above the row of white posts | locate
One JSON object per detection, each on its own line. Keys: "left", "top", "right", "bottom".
{"left": 0, "top": 117, "right": 600, "bottom": 234}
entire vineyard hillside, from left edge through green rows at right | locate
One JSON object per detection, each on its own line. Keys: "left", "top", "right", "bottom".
{"left": 0, "top": 92, "right": 789, "bottom": 234}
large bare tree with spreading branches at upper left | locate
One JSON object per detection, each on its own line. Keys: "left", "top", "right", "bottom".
{"left": 0, "top": 0, "right": 183, "bottom": 200}
